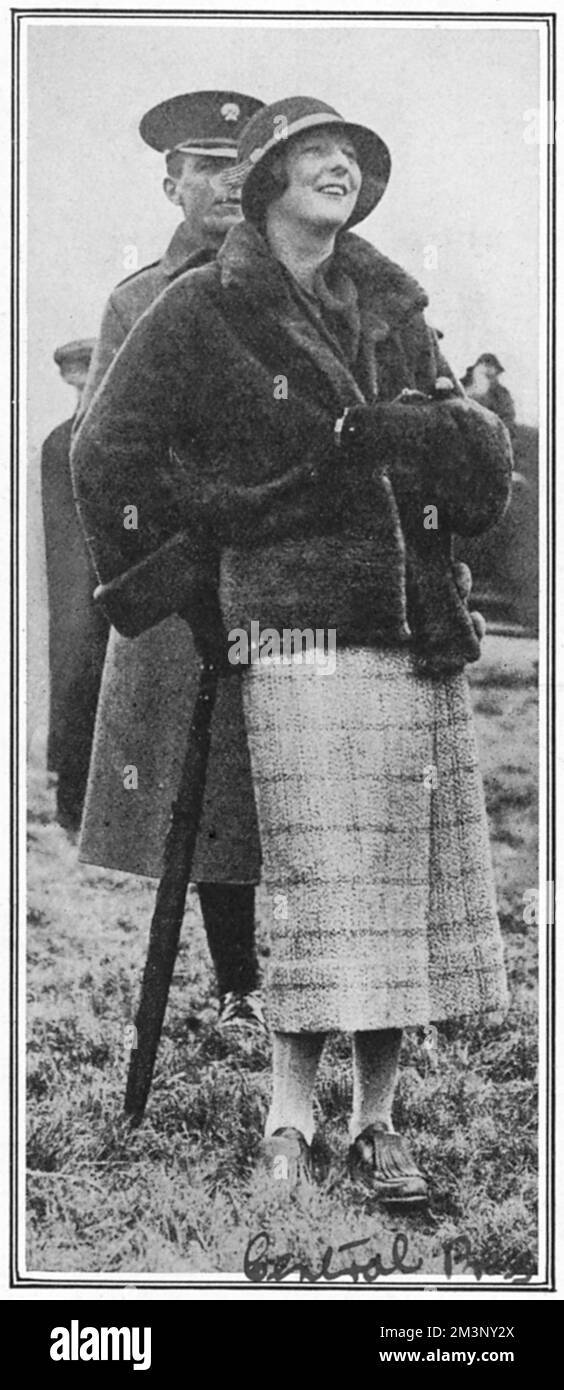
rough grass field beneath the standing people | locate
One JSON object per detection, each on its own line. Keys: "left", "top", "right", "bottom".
{"left": 26, "top": 637, "right": 538, "bottom": 1283}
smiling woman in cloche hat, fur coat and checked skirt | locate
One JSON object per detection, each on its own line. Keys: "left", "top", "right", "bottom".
{"left": 74, "top": 97, "right": 511, "bottom": 1204}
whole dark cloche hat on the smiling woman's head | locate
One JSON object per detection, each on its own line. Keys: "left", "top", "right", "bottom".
{"left": 229, "top": 96, "right": 392, "bottom": 227}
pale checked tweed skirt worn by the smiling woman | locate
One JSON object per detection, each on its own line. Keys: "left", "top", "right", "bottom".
{"left": 243, "top": 649, "right": 507, "bottom": 1033}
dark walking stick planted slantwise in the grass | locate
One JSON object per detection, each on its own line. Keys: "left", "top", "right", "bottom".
{"left": 125, "top": 663, "right": 218, "bottom": 1125}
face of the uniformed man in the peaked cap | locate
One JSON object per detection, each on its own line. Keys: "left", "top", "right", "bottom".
{"left": 164, "top": 154, "right": 242, "bottom": 246}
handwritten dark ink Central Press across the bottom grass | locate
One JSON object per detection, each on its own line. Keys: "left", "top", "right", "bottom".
{"left": 243, "top": 1230, "right": 529, "bottom": 1284}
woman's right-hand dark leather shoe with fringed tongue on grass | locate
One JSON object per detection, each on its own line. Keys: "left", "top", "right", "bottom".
{"left": 349, "top": 1125, "right": 429, "bottom": 1207}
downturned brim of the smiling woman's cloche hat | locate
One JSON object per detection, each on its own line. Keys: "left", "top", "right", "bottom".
{"left": 236, "top": 111, "right": 392, "bottom": 227}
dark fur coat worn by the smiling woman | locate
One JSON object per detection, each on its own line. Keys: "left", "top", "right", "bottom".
{"left": 74, "top": 224, "right": 511, "bottom": 673}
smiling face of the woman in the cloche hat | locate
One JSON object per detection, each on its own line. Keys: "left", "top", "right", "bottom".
{"left": 269, "top": 128, "right": 363, "bottom": 231}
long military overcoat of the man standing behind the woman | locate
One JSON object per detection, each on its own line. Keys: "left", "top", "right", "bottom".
{"left": 78, "top": 224, "right": 260, "bottom": 883}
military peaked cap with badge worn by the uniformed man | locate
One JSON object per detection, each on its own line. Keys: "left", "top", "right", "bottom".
{"left": 139, "top": 92, "right": 263, "bottom": 158}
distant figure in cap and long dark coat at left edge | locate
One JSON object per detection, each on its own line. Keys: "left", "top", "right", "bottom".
{"left": 42, "top": 338, "right": 108, "bottom": 831}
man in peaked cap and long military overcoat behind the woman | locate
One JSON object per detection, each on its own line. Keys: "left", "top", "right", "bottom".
{"left": 75, "top": 92, "right": 264, "bottom": 1029}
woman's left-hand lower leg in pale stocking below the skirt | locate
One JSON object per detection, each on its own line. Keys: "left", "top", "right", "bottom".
{"left": 265, "top": 1033, "right": 325, "bottom": 1144}
